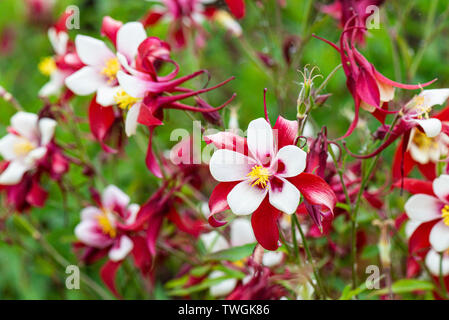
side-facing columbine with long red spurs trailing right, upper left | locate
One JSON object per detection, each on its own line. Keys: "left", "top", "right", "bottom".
{"left": 115, "top": 38, "right": 235, "bottom": 177}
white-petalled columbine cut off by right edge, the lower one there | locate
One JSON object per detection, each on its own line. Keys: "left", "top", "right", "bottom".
{"left": 405, "top": 175, "right": 449, "bottom": 252}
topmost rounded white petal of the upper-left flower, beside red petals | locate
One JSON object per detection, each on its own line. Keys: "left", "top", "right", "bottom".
{"left": 117, "top": 22, "right": 147, "bottom": 61}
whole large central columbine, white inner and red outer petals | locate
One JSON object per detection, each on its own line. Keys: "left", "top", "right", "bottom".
{"left": 205, "top": 117, "right": 336, "bottom": 250}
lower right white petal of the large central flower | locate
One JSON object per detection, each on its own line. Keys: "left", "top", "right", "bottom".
{"left": 268, "top": 178, "right": 301, "bottom": 214}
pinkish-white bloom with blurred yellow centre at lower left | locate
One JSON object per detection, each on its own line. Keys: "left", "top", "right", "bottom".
{"left": 75, "top": 185, "right": 140, "bottom": 261}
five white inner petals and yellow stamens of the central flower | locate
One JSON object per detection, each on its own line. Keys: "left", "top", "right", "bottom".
{"left": 209, "top": 118, "right": 307, "bottom": 215}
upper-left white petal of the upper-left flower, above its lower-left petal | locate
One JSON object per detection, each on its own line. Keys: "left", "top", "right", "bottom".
{"left": 75, "top": 35, "right": 115, "bottom": 67}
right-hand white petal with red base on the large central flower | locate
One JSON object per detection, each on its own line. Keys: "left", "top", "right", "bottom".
{"left": 272, "top": 145, "right": 307, "bottom": 178}
